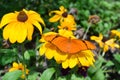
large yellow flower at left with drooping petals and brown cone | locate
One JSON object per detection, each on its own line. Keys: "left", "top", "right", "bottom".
{"left": 0, "top": 9, "right": 45, "bottom": 43}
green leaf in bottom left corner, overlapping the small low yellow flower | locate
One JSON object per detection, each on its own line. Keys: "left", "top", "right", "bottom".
{"left": 2, "top": 70, "right": 22, "bottom": 80}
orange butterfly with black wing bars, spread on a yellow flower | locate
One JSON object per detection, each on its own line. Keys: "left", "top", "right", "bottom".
{"left": 44, "top": 35, "right": 96, "bottom": 54}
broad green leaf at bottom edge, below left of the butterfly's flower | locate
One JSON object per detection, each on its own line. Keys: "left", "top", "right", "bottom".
{"left": 40, "top": 68, "right": 55, "bottom": 80}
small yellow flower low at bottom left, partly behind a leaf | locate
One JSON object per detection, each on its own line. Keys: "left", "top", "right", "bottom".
{"left": 9, "top": 62, "right": 29, "bottom": 79}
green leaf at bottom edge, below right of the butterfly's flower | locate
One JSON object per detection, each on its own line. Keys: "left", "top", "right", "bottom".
{"left": 92, "top": 69, "right": 105, "bottom": 80}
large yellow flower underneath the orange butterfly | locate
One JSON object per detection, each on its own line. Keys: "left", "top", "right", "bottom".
{"left": 39, "top": 30, "right": 95, "bottom": 69}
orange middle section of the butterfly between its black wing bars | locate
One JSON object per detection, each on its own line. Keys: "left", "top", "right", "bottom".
{"left": 52, "top": 36, "right": 87, "bottom": 54}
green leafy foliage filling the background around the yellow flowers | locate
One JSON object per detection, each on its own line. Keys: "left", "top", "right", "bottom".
{"left": 0, "top": 0, "right": 120, "bottom": 80}
